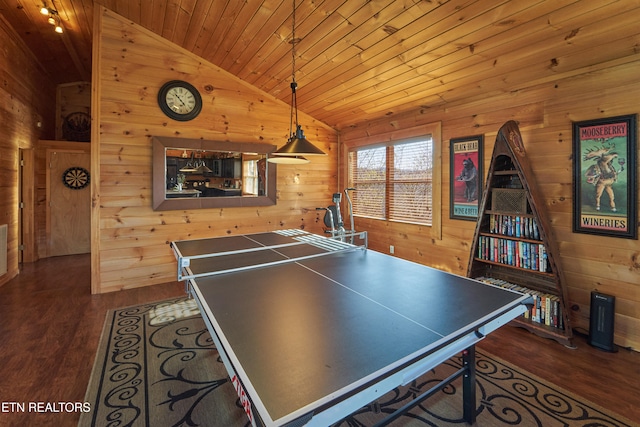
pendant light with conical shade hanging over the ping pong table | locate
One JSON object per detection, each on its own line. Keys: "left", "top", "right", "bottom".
{"left": 268, "top": 0, "right": 326, "bottom": 164}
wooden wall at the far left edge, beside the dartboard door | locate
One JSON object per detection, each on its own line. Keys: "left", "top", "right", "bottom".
{"left": 0, "top": 15, "right": 55, "bottom": 285}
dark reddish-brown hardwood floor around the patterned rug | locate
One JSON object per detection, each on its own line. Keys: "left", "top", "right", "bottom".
{"left": 0, "top": 255, "right": 640, "bottom": 426}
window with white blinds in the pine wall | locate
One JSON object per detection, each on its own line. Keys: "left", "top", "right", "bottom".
{"left": 349, "top": 136, "right": 433, "bottom": 225}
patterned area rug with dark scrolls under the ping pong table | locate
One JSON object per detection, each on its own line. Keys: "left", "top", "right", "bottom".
{"left": 79, "top": 298, "right": 631, "bottom": 427}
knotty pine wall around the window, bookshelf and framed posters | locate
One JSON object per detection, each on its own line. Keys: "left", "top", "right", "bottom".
{"left": 341, "top": 61, "right": 640, "bottom": 350}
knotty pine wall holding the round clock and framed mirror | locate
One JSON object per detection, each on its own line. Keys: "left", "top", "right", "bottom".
{"left": 91, "top": 9, "right": 338, "bottom": 293}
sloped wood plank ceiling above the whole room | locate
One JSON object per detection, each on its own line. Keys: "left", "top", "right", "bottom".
{"left": 0, "top": 0, "right": 640, "bottom": 129}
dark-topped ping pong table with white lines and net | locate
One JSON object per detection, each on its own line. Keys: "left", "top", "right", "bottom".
{"left": 171, "top": 230, "right": 531, "bottom": 427}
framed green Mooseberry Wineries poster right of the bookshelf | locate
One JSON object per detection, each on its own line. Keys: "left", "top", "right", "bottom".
{"left": 573, "top": 114, "right": 638, "bottom": 239}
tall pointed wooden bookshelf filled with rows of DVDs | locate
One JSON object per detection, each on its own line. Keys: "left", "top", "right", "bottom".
{"left": 467, "top": 121, "right": 573, "bottom": 347}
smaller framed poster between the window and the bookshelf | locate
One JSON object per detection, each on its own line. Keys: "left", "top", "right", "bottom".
{"left": 449, "top": 135, "right": 484, "bottom": 221}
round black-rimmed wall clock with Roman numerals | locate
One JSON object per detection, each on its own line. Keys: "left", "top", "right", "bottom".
{"left": 158, "top": 80, "right": 202, "bottom": 121}
